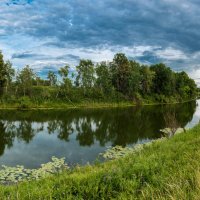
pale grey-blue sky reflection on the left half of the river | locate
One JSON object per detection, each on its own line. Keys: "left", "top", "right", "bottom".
{"left": 0, "top": 119, "right": 111, "bottom": 168}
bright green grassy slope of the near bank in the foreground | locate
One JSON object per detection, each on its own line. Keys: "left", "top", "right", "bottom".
{"left": 0, "top": 125, "right": 200, "bottom": 200}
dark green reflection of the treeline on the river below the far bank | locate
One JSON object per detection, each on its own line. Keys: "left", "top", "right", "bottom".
{"left": 0, "top": 102, "right": 196, "bottom": 155}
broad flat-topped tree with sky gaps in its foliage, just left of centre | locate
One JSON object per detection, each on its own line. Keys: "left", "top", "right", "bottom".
{"left": 76, "top": 60, "right": 95, "bottom": 93}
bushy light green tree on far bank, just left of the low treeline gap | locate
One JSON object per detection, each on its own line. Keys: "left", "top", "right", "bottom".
{"left": 17, "top": 65, "right": 35, "bottom": 96}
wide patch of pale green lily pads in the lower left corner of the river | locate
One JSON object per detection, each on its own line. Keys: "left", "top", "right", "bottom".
{"left": 0, "top": 157, "right": 69, "bottom": 185}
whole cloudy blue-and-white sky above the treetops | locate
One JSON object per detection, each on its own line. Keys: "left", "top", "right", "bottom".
{"left": 0, "top": 0, "right": 200, "bottom": 85}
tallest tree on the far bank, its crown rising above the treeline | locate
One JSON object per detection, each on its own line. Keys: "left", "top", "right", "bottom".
{"left": 111, "top": 53, "right": 130, "bottom": 94}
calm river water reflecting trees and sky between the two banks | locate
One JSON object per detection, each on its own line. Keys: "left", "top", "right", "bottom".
{"left": 0, "top": 101, "right": 200, "bottom": 168}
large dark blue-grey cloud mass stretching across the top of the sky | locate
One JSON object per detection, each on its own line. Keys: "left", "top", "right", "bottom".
{"left": 1, "top": 0, "right": 200, "bottom": 52}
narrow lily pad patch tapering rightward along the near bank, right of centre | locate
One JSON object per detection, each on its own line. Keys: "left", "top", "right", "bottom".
{"left": 100, "top": 137, "right": 166, "bottom": 160}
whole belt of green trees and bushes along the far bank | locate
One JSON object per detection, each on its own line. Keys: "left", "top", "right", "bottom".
{"left": 0, "top": 52, "right": 197, "bottom": 108}
